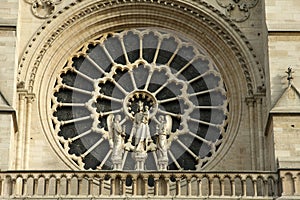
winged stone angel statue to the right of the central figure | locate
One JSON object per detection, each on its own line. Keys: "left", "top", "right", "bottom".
{"left": 156, "top": 115, "right": 172, "bottom": 170}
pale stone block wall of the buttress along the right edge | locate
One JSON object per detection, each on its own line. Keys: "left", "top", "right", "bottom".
{"left": 266, "top": 0, "right": 300, "bottom": 168}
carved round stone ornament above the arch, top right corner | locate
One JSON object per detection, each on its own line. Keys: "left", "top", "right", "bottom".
{"left": 217, "top": 0, "right": 258, "bottom": 22}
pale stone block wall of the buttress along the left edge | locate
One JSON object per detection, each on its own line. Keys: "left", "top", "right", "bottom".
{"left": 0, "top": 0, "right": 18, "bottom": 170}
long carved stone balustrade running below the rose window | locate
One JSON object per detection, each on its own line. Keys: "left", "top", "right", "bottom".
{"left": 0, "top": 171, "right": 278, "bottom": 199}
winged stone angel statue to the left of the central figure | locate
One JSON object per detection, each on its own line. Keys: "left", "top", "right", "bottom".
{"left": 107, "top": 114, "right": 126, "bottom": 170}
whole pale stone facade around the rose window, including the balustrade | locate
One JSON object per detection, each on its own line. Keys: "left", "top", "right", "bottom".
{"left": 0, "top": 0, "right": 300, "bottom": 199}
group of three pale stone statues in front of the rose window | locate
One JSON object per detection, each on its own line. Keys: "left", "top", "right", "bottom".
{"left": 107, "top": 101, "right": 172, "bottom": 171}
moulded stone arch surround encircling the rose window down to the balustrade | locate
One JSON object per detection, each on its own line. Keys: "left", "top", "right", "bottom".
{"left": 18, "top": 0, "right": 264, "bottom": 169}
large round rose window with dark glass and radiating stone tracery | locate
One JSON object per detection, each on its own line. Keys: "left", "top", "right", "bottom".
{"left": 51, "top": 29, "right": 228, "bottom": 170}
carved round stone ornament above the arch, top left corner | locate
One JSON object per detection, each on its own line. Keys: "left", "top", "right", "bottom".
{"left": 25, "top": 0, "right": 62, "bottom": 19}
